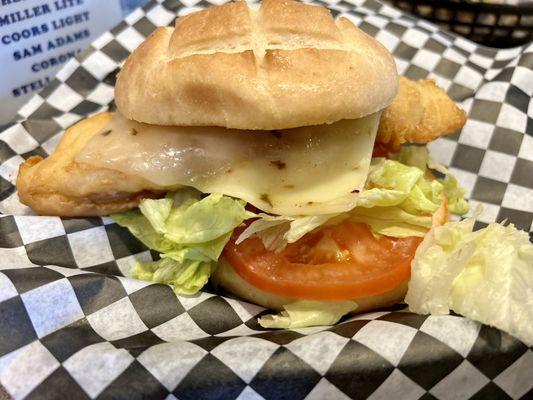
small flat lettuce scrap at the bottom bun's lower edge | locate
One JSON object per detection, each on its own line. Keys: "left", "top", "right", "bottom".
{"left": 258, "top": 300, "right": 357, "bottom": 329}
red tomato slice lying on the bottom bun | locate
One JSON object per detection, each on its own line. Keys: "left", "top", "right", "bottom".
{"left": 224, "top": 220, "right": 421, "bottom": 300}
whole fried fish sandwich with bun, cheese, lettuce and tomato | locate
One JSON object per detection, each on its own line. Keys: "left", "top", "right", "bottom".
{"left": 17, "top": 0, "right": 468, "bottom": 327}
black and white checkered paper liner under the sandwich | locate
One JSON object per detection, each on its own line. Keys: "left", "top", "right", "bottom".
{"left": 0, "top": 0, "right": 533, "bottom": 399}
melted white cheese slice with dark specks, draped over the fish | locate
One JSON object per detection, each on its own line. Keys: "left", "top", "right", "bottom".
{"left": 76, "top": 113, "right": 380, "bottom": 215}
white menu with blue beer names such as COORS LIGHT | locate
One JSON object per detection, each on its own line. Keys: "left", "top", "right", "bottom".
{"left": 0, "top": 0, "right": 144, "bottom": 125}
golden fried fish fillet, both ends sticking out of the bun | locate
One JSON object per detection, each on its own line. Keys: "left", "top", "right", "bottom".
{"left": 17, "top": 78, "right": 466, "bottom": 216}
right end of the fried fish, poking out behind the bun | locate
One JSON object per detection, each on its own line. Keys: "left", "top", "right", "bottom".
{"left": 376, "top": 77, "right": 466, "bottom": 150}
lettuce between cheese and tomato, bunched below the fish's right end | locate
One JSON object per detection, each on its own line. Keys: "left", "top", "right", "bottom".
{"left": 237, "top": 146, "right": 468, "bottom": 251}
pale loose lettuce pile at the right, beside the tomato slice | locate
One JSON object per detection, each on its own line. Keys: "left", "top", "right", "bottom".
{"left": 405, "top": 218, "right": 533, "bottom": 346}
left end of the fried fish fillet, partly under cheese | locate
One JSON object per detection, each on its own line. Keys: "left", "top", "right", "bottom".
{"left": 17, "top": 113, "right": 163, "bottom": 217}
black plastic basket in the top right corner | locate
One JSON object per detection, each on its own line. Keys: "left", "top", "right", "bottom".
{"left": 387, "top": 0, "right": 533, "bottom": 48}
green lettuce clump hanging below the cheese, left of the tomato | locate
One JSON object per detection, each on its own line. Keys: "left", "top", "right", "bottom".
{"left": 111, "top": 189, "right": 255, "bottom": 295}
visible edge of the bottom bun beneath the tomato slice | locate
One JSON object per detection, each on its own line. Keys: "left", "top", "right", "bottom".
{"left": 211, "top": 257, "right": 408, "bottom": 313}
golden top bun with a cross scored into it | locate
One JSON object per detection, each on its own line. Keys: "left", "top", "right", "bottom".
{"left": 115, "top": 0, "right": 398, "bottom": 129}
